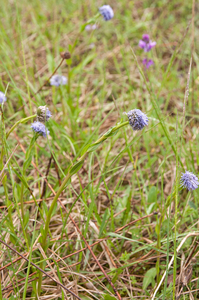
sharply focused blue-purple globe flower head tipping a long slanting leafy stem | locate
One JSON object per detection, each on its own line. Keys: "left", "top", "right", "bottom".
{"left": 127, "top": 109, "right": 149, "bottom": 130}
